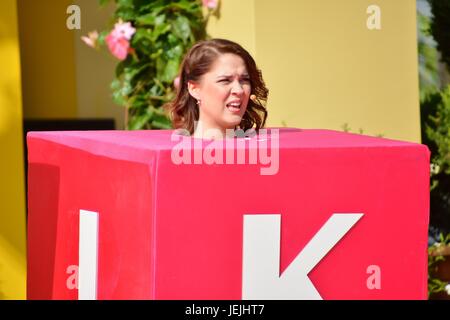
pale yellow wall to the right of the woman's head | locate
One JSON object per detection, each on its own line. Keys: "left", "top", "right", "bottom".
{"left": 208, "top": 0, "right": 420, "bottom": 142}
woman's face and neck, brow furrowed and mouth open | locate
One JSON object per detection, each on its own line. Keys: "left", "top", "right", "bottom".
{"left": 189, "top": 53, "right": 251, "bottom": 130}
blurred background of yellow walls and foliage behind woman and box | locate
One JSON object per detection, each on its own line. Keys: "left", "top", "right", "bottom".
{"left": 0, "top": 0, "right": 450, "bottom": 299}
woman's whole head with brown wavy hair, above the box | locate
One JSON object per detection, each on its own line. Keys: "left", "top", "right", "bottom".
{"left": 167, "top": 39, "right": 268, "bottom": 134}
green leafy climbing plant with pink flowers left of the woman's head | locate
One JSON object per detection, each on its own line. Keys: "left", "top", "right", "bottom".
{"left": 98, "top": 0, "right": 206, "bottom": 130}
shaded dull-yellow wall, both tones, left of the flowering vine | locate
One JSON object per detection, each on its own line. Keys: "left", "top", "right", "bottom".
{"left": 18, "top": 0, "right": 125, "bottom": 129}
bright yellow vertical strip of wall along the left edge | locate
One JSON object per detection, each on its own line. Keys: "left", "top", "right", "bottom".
{"left": 0, "top": 0, "right": 26, "bottom": 299}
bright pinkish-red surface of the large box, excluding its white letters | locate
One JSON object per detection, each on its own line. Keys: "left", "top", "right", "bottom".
{"left": 27, "top": 129, "right": 429, "bottom": 299}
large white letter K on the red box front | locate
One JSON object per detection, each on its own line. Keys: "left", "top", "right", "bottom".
{"left": 242, "top": 213, "right": 363, "bottom": 300}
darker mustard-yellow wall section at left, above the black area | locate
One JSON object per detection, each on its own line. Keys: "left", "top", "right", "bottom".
{"left": 18, "top": 0, "right": 77, "bottom": 118}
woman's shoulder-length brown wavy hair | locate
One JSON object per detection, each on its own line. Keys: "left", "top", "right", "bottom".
{"left": 164, "top": 39, "right": 269, "bottom": 134}
